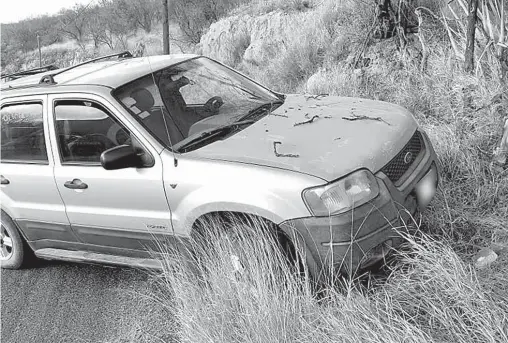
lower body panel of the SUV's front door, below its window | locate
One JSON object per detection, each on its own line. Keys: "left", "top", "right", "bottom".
{"left": 55, "top": 163, "right": 171, "bottom": 249}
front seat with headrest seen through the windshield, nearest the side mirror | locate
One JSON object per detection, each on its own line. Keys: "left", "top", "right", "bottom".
{"left": 130, "top": 88, "right": 185, "bottom": 146}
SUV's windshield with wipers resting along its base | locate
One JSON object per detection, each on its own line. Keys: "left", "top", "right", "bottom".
{"left": 115, "top": 57, "right": 282, "bottom": 151}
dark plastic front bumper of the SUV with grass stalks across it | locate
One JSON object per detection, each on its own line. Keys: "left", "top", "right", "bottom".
{"left": 279, "top": 130, "right": 439, "bottom": 279}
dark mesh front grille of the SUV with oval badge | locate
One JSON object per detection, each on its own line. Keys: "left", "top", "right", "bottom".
{"left": 381, "top": 131, "right": 425, "bottom": 186}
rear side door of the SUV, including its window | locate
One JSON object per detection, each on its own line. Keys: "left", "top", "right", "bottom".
{"left": 0, "top": 95, "right": 78, "bottom": 247}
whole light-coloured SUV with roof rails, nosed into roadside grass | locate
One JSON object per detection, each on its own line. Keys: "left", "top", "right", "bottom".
{"left": 0, "top": 52, "right": 438, "bottom": 273}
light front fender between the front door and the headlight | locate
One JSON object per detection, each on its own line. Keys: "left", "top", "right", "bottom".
{"left": 164, "top": 157, "right": 323, "bottom": 236}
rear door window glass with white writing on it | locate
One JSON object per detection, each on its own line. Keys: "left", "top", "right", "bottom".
{"left": 0, "top": 102, "right": 48, "bottom": 163}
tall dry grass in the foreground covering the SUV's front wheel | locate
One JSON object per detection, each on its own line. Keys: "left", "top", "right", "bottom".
{"left": 154, "top": 221, "right": 508, "bottom": 343}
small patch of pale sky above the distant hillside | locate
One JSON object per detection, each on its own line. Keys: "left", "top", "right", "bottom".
{"left": 0, "top": 0, "right": 92, "bottom": 24}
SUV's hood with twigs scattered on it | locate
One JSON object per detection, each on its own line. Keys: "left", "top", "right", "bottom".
{"left": 186, "top": 95, "right": 417, "bottom": 181}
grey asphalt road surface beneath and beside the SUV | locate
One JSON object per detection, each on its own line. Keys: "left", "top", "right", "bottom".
{"left": 0, "top": 261, "right": 174, "bottom": 343}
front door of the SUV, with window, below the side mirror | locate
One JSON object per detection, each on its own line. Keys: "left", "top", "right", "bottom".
{"left": 48, "top": 94, "right": 172, "bottom": 252}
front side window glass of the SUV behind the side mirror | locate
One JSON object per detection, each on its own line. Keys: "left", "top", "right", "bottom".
{"left": 54, "top": 100, "right": 130, "bottom": 164}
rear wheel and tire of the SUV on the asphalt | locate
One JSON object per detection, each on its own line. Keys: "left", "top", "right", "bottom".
{"left": 0, "top": 211, "right": 30, "bottom": 269}
